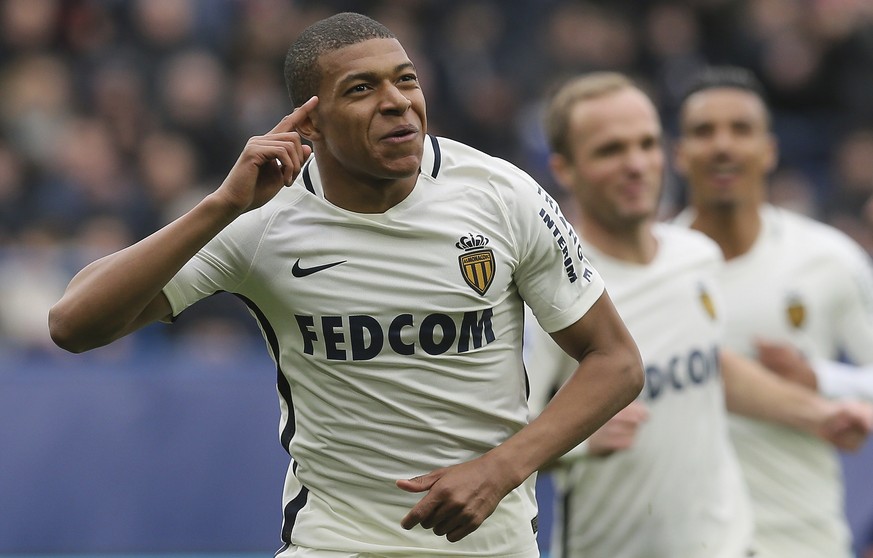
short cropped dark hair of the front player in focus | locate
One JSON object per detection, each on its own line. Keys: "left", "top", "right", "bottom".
{"left": 285, "top": 12, "right": 397, "bottom": 107}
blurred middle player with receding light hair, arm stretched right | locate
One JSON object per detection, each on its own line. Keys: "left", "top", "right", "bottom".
{"left": 526, "top": 73, "right": 871, "bottom": 558}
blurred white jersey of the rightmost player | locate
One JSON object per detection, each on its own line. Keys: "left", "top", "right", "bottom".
{"left": 678, "top": 206, "right": 873, "bottom": 558}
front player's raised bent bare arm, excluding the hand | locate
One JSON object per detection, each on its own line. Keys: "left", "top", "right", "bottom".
{"left": 49, "top": 196, "right": 239, "bottom": 352}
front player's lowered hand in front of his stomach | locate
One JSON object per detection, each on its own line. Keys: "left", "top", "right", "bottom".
{"left": 397, "top": 455, "right": 515, "bottom": 542}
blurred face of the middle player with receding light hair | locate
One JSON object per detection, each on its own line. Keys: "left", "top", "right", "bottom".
{"left": 551, "top": 87, "right": 664, "bottom": 230}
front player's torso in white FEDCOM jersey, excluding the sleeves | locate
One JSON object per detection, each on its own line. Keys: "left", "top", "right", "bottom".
{"left": 247, "top": 151, "right": 536, "bottom": 556}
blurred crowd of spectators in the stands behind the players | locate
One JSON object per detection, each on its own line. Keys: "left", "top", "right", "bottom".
{"left": 0, "top": 0, "right": 873, "bottom": 358}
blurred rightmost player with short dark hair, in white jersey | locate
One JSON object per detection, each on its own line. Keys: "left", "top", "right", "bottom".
{"left": 676, "top": 67, "right": 873, "bottom": 558}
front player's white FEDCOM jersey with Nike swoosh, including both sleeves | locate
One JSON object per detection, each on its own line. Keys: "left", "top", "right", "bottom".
{"left": 164, "top": 136, "right": 603, "bottom": 557}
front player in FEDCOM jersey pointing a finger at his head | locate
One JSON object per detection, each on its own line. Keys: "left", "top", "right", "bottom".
{"left": 49, "top": 13, "right": 643, "bottom": 557}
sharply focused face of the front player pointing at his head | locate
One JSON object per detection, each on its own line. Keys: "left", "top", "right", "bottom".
{"left": 308, "top": 39, "right": 427, "bottom": 185}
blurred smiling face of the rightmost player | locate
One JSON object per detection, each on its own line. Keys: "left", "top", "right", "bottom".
{"left": 676, "top": 87, "right": 776, "bottom": 212}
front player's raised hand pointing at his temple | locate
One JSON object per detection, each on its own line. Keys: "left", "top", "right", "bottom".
{"left": 216, "top": 97, "right": 318, "bottom": 214}
